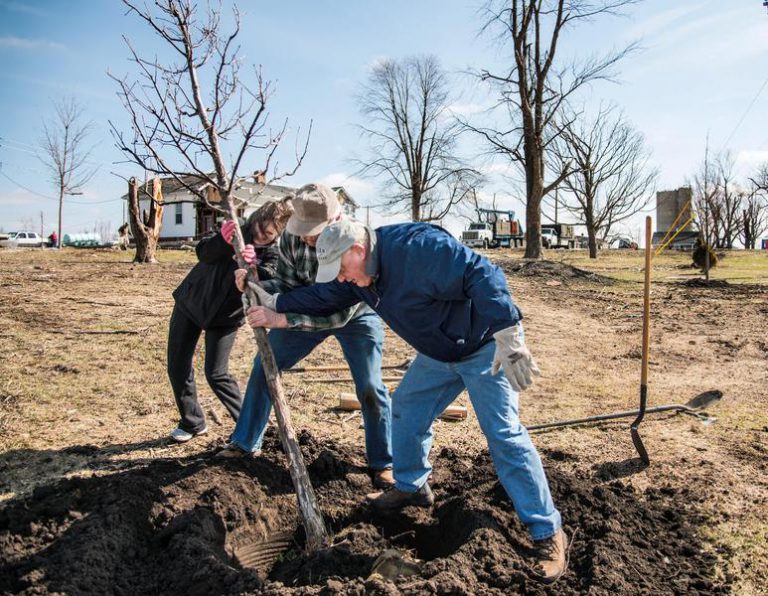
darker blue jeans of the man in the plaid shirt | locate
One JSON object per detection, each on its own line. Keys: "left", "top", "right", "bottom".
{"left": 231, "top": 312, "right": 392, "bottom": 470}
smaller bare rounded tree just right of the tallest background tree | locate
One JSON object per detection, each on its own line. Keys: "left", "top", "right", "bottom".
{"left": 551, "top": 107, "right": 658, "bottom": 259}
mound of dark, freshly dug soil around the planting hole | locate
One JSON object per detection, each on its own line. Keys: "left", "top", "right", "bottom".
{"left": 0, "top": 434, "right": 727, "bottom": 595}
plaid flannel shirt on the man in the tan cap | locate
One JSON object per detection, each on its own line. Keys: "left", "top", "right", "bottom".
{"left": 261, "top": 231, "right": 370, "bottom": 331}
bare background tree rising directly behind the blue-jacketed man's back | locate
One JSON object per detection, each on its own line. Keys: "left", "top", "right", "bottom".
{"left": 355, "top": 56, "right": 479, "bottom": 221}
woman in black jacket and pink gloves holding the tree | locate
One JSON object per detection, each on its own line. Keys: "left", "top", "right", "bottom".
{"left": 168, "top": 197, "right": 292, "bottom": 443}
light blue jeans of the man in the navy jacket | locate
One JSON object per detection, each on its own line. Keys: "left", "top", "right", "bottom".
{"left": 392, "top": 342, "right": 561, "bottom": 540}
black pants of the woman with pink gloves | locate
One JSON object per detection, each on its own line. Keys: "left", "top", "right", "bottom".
{"left": 168, "top": 306, "right": 243, "bottom": 433}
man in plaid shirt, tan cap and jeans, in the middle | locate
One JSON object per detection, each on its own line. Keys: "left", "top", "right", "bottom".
{"left": 219, "top": 184, "right": 394, "bottom": 488}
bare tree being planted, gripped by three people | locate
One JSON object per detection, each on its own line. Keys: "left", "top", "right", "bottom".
{"left": 110, "top": 0, "right": 328, "bottom": 548}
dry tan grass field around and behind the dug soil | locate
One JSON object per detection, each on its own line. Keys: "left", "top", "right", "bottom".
{"left": 0, "top": 244, "right": 768, "bottom": 594}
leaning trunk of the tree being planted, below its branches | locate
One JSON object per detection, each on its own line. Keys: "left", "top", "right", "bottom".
{"left": 221, "top": 208, "right": 330, "bottom": 551}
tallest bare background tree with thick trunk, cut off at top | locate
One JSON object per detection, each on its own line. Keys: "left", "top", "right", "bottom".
{"left": 465, "top": 0, "right": 638, "bottom": 259}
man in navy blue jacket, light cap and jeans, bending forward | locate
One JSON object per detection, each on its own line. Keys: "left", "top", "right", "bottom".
{"left": 248, "top": 221, "right": 567, "bottom": 583}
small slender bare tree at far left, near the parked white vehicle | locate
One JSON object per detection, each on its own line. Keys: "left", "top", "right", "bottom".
{"left": 40, "top": 97, "right": 97, "bottom": 247}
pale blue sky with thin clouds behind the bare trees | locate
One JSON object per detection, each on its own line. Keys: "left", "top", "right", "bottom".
{"left": 0, "top": 0, "right": 768, "bottom": 240}
